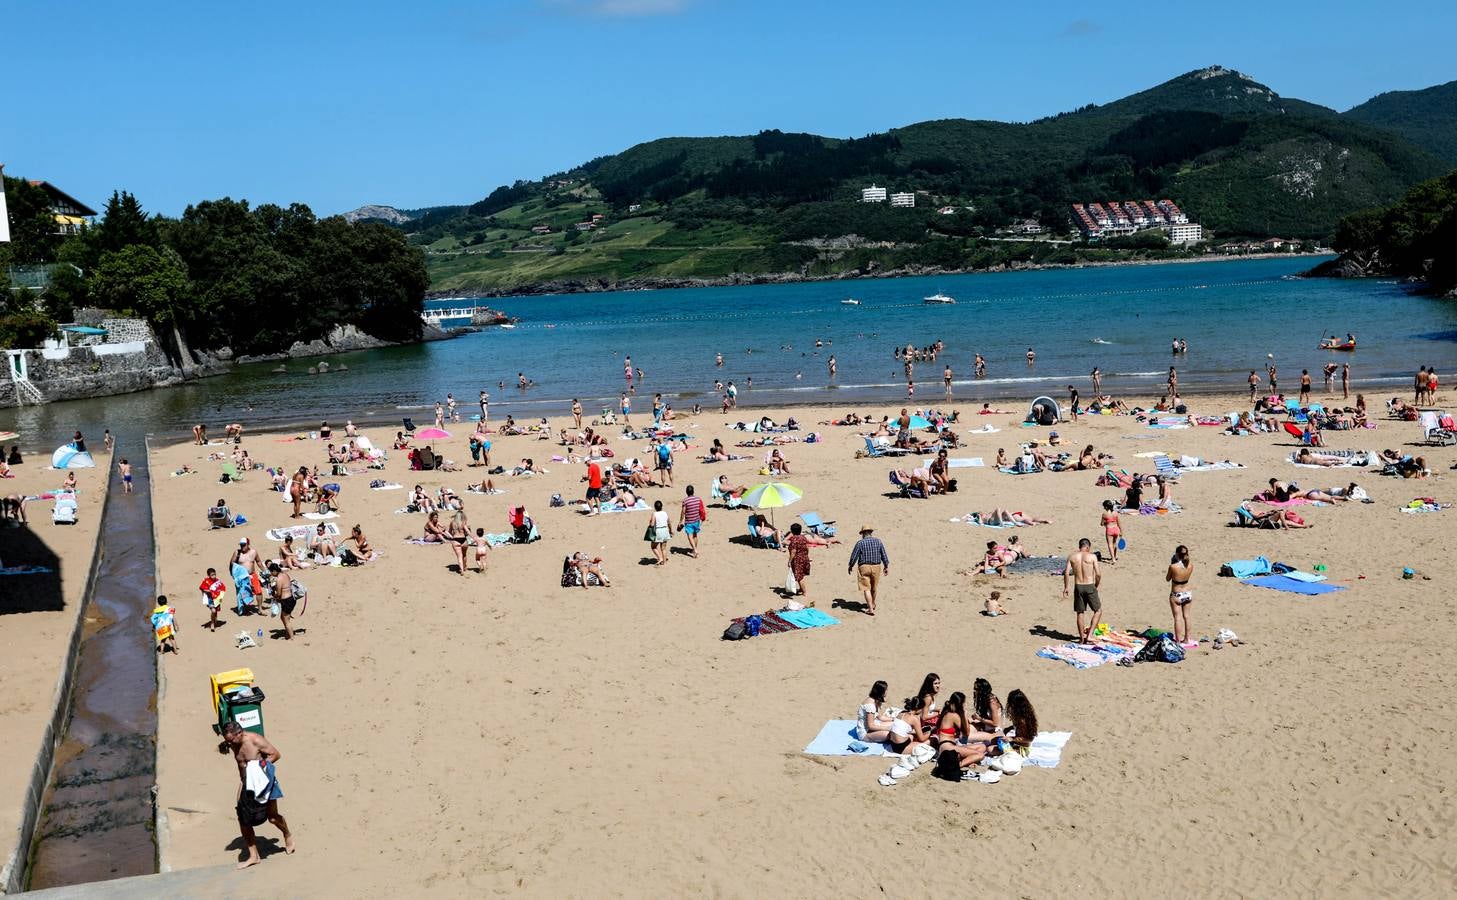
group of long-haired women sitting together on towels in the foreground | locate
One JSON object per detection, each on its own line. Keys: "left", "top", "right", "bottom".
{"left": 855, "top": 673, "right": 1037, "bottom": 770}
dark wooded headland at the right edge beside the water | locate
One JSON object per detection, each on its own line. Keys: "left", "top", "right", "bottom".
{"left": 1323, "top": 170, "right": 1457, "bottom": 293}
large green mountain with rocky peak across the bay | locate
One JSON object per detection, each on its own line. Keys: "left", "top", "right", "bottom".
{"left": 401, "top": 67, "right": 1447, "bottom": 290}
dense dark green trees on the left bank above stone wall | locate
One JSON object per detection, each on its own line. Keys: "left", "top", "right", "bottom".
{"left": 0, "top": 178, "right": 428, "bottom": 353}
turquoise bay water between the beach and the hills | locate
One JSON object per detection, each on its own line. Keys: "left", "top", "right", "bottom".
{"left": 0, "top": 258, "right": 1457, "bottom": 440}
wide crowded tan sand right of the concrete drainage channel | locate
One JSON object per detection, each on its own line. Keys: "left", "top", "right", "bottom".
{"left": 152, "top": 398, "right": 1457, "bottom": 897}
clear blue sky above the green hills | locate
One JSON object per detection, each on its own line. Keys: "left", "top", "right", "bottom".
{"left": 0, "top": 0, "right": 1457, "bottom": 214}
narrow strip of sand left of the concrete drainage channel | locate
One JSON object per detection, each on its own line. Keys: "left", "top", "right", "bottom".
{"left": 0, "top": 450, "right": 111, "bottom": 865}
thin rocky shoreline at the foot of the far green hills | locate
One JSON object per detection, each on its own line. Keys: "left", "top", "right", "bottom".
{"left": 425, "top": 253, "right": 1332, "bottom": 300}
